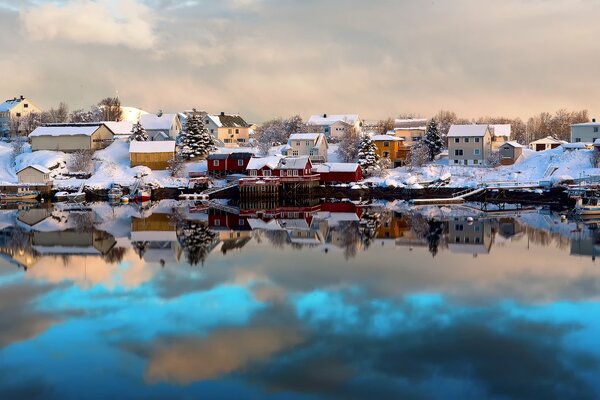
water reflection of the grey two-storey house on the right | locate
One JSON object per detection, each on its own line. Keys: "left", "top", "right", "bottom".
{"left": 448, "top": 218, "right": 493, "bottom": 255}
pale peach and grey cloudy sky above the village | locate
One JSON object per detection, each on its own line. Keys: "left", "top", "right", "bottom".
{"left": 0, "top": 0, "right": 600, "bottom": 122}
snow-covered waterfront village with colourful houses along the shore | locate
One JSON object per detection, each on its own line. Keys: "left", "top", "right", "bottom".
{"left": 0, "top": 96, "right": 600, "bottom": 211}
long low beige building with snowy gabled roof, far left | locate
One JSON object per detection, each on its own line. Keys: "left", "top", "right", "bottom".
{"left": 29, "top": 122, "right": 114, "bottom": 153}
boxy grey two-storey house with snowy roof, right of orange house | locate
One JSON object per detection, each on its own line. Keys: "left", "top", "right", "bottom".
{"left": 448, "top": 124, "right": 492, "bottom": 166}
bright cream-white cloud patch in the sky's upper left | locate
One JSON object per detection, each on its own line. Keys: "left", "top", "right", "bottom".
{"left": 20, "top": 0, "right": 157, "bottom": 49}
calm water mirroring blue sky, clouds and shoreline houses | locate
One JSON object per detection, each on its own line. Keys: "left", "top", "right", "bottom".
{"left": 0, "top": 202, "right": 600, "bottom": 399}
